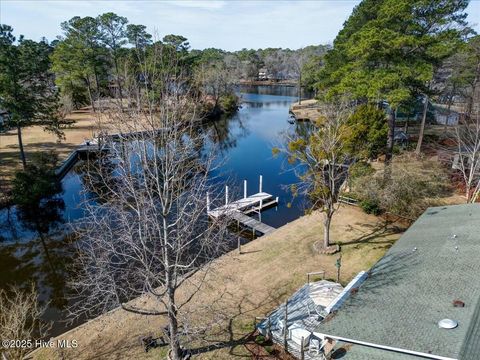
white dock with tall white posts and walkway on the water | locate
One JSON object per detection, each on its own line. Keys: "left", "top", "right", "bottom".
{"left": 207, "top": 175, "right": 278, "bottom": 235}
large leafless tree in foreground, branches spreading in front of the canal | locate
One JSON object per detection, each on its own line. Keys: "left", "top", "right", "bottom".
{"left": 72, "top": 48, "right": 231, "bottom": 360}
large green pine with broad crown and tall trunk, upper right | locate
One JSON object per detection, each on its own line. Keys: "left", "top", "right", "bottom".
{"left": 320, "top": 0, "right": 468, "bottom": 163}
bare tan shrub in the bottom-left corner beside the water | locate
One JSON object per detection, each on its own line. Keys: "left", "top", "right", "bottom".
{"left": 0, "top": 284, "right": 47, "bottom": 360}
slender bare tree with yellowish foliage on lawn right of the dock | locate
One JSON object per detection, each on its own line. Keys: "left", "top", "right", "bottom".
{"left": 274, "top": 101, "right": 352, "bottom": 248}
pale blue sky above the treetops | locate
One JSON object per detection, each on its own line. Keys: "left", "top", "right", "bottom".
{"left": 0, "top": 0, "right": 480, "bottom": 50}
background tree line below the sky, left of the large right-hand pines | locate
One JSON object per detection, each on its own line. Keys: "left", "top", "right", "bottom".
{"left": 0, "top": 12, "right": 327, "bottom": 167}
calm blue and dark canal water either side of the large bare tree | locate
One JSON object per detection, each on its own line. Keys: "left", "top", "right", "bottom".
{"left": 0, "top": 86, "right": 303, "bottom": 335}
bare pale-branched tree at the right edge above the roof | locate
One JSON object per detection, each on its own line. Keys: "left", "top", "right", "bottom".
{"left": 453, "top": 113, "right": 480, "bottom": 203}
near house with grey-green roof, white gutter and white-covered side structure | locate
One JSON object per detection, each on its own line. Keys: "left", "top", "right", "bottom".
{"left": 260, "top": 204, "right": 480, "bottom": 360}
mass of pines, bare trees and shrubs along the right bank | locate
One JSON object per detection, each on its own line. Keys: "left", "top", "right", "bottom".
{"left": 274, "top": 0, "right": 480, "bottom": 252}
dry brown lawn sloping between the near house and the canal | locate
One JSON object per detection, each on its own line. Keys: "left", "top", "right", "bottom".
{"left": 30, "top": 206, "right": 403, "bottom": 359}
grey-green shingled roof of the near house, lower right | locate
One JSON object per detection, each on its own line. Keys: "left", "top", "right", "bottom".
{"left": 317, "top": 204, "right": 480, "bottom": 360}
